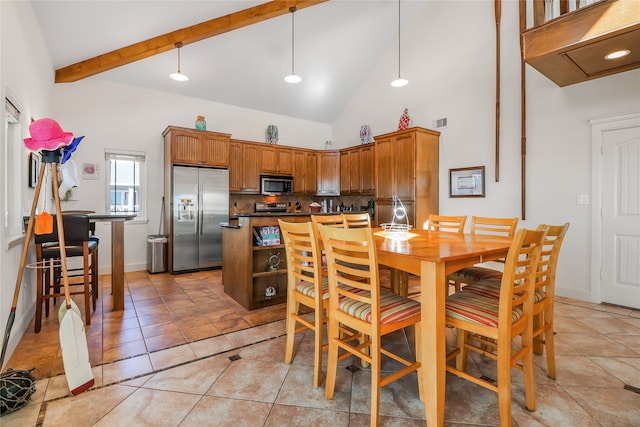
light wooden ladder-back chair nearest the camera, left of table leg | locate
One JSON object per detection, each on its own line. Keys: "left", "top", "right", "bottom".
{"left": 319, "top": 225, "right": 424, "bottom": 426}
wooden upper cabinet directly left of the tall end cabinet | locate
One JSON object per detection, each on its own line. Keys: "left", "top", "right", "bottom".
{"left": 340, "top": 144, "right": 375, "bottom": 195}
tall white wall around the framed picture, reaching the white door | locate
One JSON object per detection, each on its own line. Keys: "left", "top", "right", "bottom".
{"left": 333, "top": 1, "right": 640, "bottom": 300}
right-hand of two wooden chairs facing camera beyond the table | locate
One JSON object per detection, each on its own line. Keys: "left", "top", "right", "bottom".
{"left": 448, "top": 216, "right": 518, "bottom": 292}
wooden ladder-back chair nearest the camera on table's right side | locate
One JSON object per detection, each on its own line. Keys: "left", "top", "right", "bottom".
{"left": 445, "top": 229, "right": 546, "bottom": 426}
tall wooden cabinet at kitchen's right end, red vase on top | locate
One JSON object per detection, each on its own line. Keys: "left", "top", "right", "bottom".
{"left": 374, "top": 127, "right": 440, "bottom": 228}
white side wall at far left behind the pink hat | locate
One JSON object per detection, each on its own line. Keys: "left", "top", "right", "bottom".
{"left": 0, "top": 1, "right": 55, "bottom": 363}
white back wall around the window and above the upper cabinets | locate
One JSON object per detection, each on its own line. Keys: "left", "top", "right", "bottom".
{"left": 54, "top": 77, "right": 331, "bottom": 273}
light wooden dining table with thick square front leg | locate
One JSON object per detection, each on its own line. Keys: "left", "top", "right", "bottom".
{"left": 374, "top": 229, "right": 510, "bottom": 426}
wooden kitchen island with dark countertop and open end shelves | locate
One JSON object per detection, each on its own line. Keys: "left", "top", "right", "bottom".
{"left": 221, "top": 212, "right": 338, "bottom": 310}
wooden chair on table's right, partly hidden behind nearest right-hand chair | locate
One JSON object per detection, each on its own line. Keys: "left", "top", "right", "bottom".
{"left": 463, "top": 222, "right": 569, "bottom": 378}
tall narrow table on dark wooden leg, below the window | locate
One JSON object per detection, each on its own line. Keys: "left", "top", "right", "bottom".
{"left": 88, "top": 212, "right": 136, "bottom": 311}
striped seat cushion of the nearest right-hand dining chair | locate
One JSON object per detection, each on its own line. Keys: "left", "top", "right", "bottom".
{"left": 445, "top": 292, "right": 522, "bottom": 328}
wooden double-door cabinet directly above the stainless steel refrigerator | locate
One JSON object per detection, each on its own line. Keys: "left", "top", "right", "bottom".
{"left": 162, "top": 126, "right": 231, "bottom": 168}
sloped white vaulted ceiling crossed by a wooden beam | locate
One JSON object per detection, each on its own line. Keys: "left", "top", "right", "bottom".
{"left": 32, "top": 0, "right": 429, "bottom": 123}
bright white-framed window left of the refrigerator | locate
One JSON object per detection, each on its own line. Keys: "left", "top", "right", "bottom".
{"left": 105, "top": 150, "right": 147, "bottom": 220}
